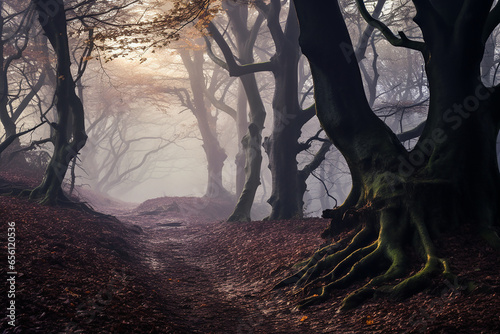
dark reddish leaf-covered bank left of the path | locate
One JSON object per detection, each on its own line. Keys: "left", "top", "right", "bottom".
{"left": 0, "top": 196, "right": 190, "bottom": 333}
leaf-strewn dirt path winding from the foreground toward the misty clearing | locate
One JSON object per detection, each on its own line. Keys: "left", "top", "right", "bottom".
{"left": 114, "top": 212, "right": 286, "bottom": 333}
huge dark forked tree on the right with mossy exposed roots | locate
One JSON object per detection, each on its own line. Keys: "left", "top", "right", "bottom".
{"left": 277, "top": 0, "right": 500, "bottom": 309}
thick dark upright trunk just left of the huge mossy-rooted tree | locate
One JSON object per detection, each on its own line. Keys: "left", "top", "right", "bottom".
{"left": 264, "top": 1, "right": 306, "bottom": 220}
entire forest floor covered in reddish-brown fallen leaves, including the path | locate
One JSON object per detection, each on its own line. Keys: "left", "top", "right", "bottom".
{"left": 0, "top": 168, "right": 500, "bottom": 333}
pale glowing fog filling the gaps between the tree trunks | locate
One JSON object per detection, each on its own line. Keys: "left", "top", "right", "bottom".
{"left": 3, "top": 2, "right": 500, "bottom": 216}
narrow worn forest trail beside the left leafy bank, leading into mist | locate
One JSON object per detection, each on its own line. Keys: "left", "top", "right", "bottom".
{"left": 120, "top": 214, "right": 260, "bottom": 333}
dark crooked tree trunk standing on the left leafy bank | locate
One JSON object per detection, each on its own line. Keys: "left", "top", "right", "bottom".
{"left": 30, "top": 0, "right": 87, "bottom": 204}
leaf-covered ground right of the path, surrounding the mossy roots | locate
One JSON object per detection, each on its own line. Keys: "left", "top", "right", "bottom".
{"left": 200, "top": 220, "right": 500, "bottom": 333}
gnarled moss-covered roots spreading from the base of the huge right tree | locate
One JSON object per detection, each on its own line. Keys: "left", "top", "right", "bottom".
{"left": 275, "top": 203, "right": 456, "bottom": 310}
